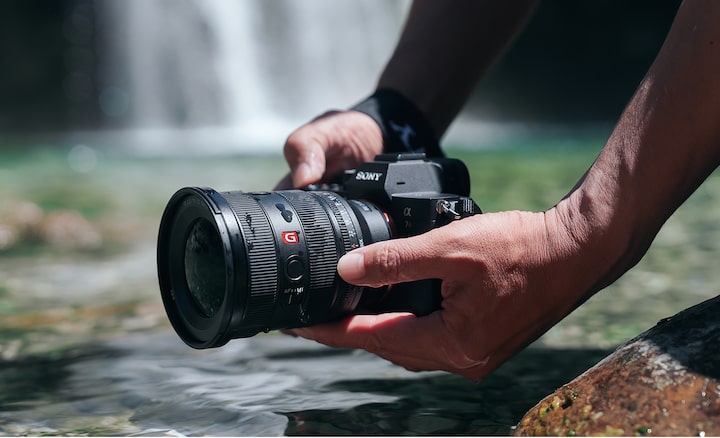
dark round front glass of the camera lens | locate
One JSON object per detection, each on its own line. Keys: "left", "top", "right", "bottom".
{"left": 185, "top": 219, "right": 225, "bottom": 318}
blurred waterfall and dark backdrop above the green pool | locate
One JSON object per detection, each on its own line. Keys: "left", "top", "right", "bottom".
{"left": 0, "top": 0, "right": 679, "bottom": 152}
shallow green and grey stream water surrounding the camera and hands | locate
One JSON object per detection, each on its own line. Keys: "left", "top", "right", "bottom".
{"left": 0, "top": 145, "right": 720, "bottom": 435}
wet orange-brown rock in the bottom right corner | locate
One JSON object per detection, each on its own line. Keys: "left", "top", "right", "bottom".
{"left": 515, "top": 296, "right": 720, "bottom": 436}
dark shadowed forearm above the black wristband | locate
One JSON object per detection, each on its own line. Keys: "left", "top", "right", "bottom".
{"left": 378, "top": 0, "right": 535, "bottom": 137}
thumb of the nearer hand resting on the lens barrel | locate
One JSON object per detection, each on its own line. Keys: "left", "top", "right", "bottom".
{"left": 337, "top": 233, "right": 447, "bottom": 287}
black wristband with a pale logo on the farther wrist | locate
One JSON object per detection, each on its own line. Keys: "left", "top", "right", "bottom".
{"left": 351, "top": 88, "right": 445, "bottom": 158}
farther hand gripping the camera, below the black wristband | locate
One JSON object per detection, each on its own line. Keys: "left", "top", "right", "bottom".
{"left": 276, "top": 111, "right": 383, "bottom": 190}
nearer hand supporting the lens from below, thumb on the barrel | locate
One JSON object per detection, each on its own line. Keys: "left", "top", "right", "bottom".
{"left": 289, "top": 204, "right": 603, "bottom": 380}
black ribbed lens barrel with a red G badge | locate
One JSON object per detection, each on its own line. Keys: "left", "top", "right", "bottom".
{"left": 157, "top": 187, "right": 391, "bottom": 348}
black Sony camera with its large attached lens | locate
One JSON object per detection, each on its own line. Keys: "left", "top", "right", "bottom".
{"left": 157, "top": 154, "right": 480, "bottom": 348}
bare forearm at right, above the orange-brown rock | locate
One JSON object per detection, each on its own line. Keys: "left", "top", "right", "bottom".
{"left": 563, "top": 0, "right": 720, "bottom": 298}
